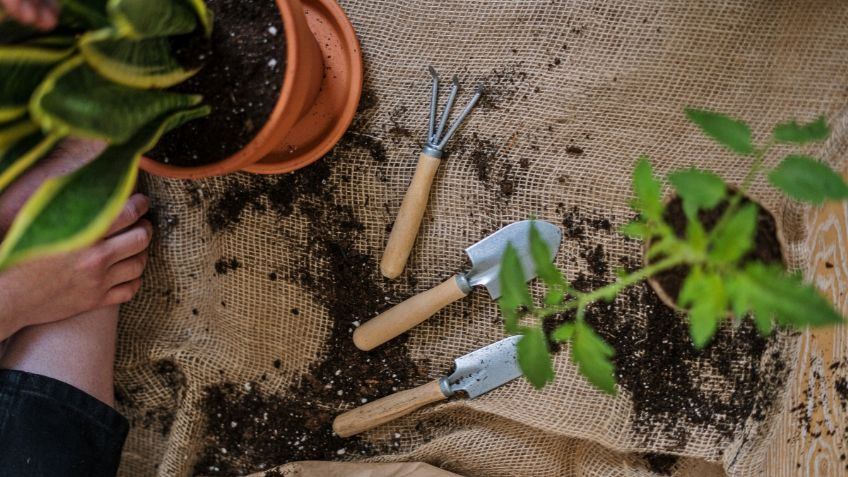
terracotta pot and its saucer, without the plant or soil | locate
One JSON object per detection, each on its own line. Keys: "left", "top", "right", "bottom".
{"left": 141, "top": 0, "right": 362, "bottom": 179}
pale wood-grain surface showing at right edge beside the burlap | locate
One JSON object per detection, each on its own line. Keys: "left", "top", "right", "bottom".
{"left": 763, "top": 165, "right": 848, "bottom": 477}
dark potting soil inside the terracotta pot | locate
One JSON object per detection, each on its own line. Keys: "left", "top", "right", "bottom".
{"left": 148, "top": 0, "right": 286, "bottom": 166}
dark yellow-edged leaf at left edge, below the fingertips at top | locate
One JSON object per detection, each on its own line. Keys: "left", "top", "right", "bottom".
{"left": 0, "top": 45, "right": 72, "bottom": 123}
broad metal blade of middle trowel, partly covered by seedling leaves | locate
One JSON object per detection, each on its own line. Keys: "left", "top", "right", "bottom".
{"left": 465, "top": 220, "right": 562, "bottom": 300}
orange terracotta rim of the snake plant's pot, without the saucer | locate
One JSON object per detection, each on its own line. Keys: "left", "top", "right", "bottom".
{"left": 140, "top": 0, "right": 303, "bottom": 179}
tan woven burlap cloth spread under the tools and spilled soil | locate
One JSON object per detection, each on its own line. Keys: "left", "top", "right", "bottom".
{"left": 116, "top": 0, "right": 848, "bottom": 477}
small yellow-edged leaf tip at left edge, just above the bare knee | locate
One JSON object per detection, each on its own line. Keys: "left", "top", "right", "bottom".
{"left": 0, "top": 118, "right": 59, "bottom": 191}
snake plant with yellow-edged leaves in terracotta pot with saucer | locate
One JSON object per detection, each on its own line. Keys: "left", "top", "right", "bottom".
{"left": 0, "top": 0, "right": 362, "bottom": 268}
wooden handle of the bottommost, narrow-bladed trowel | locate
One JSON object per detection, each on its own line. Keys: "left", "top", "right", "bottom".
{"left": 333, "top": 379, "right": 447, "bottom": 437}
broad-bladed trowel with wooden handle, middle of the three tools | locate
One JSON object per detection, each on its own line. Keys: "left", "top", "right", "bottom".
{"left": 353, "top": 220, "right": 562, "bottom": 351}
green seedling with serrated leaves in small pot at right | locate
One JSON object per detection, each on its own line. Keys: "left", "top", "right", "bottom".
{"left": 499, "top": 109, "right": 848, "bottom": 394}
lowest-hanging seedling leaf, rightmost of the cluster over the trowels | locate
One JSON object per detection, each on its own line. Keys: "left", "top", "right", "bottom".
{"left": 571, "top": 322, "right": 616, "bottom": 396}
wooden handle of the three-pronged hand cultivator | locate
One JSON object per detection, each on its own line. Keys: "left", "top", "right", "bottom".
{"left": 380, "top": 153, "right": 441, "bottom": 278}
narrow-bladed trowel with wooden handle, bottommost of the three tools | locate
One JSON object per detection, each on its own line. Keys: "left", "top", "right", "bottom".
{"left": 333, "top": 336, "right": 521, "bottom": 437}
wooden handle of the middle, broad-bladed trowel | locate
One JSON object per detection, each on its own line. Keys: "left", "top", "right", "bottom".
{"left": 353, "top": 275, "right": 470, "bottom": 351}
